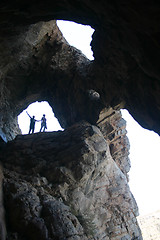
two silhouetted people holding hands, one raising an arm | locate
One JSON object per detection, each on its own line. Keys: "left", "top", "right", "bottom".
{"left": 26, "top": 112, "right": 47, "bottom": 134}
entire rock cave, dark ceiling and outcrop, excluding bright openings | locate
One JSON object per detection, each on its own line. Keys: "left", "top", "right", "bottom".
{"left": 0, "top": 0, "right": 160, "bottom": 240}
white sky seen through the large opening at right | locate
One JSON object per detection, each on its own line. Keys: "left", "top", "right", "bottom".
{"left": 122, "top": 110, "right": 160, "bottom": 215}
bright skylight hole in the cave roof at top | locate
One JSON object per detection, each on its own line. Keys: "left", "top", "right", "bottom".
{"left": 57, "top": 20, "right": 94, "bottom": 60}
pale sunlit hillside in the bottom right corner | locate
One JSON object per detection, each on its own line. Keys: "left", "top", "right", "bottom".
{"left": 137, "top": 211, "right": 160, "bottom": 240}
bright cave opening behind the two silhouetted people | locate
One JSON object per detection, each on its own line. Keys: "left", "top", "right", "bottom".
{"left": 18, "top": 101, "right": 63, "bottom": 134}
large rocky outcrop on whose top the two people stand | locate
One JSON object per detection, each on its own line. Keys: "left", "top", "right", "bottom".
{"left": 1, "top": 122, "right": 141, "bottom": 240}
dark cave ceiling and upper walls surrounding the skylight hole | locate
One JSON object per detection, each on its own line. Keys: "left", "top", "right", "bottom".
{"left": 0, "top": 0, "right": 160, "bottom": 139}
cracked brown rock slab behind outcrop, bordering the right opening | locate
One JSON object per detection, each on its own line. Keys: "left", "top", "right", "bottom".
{"left": 97, "top": 108, "right": 131, "bottom": 178}
